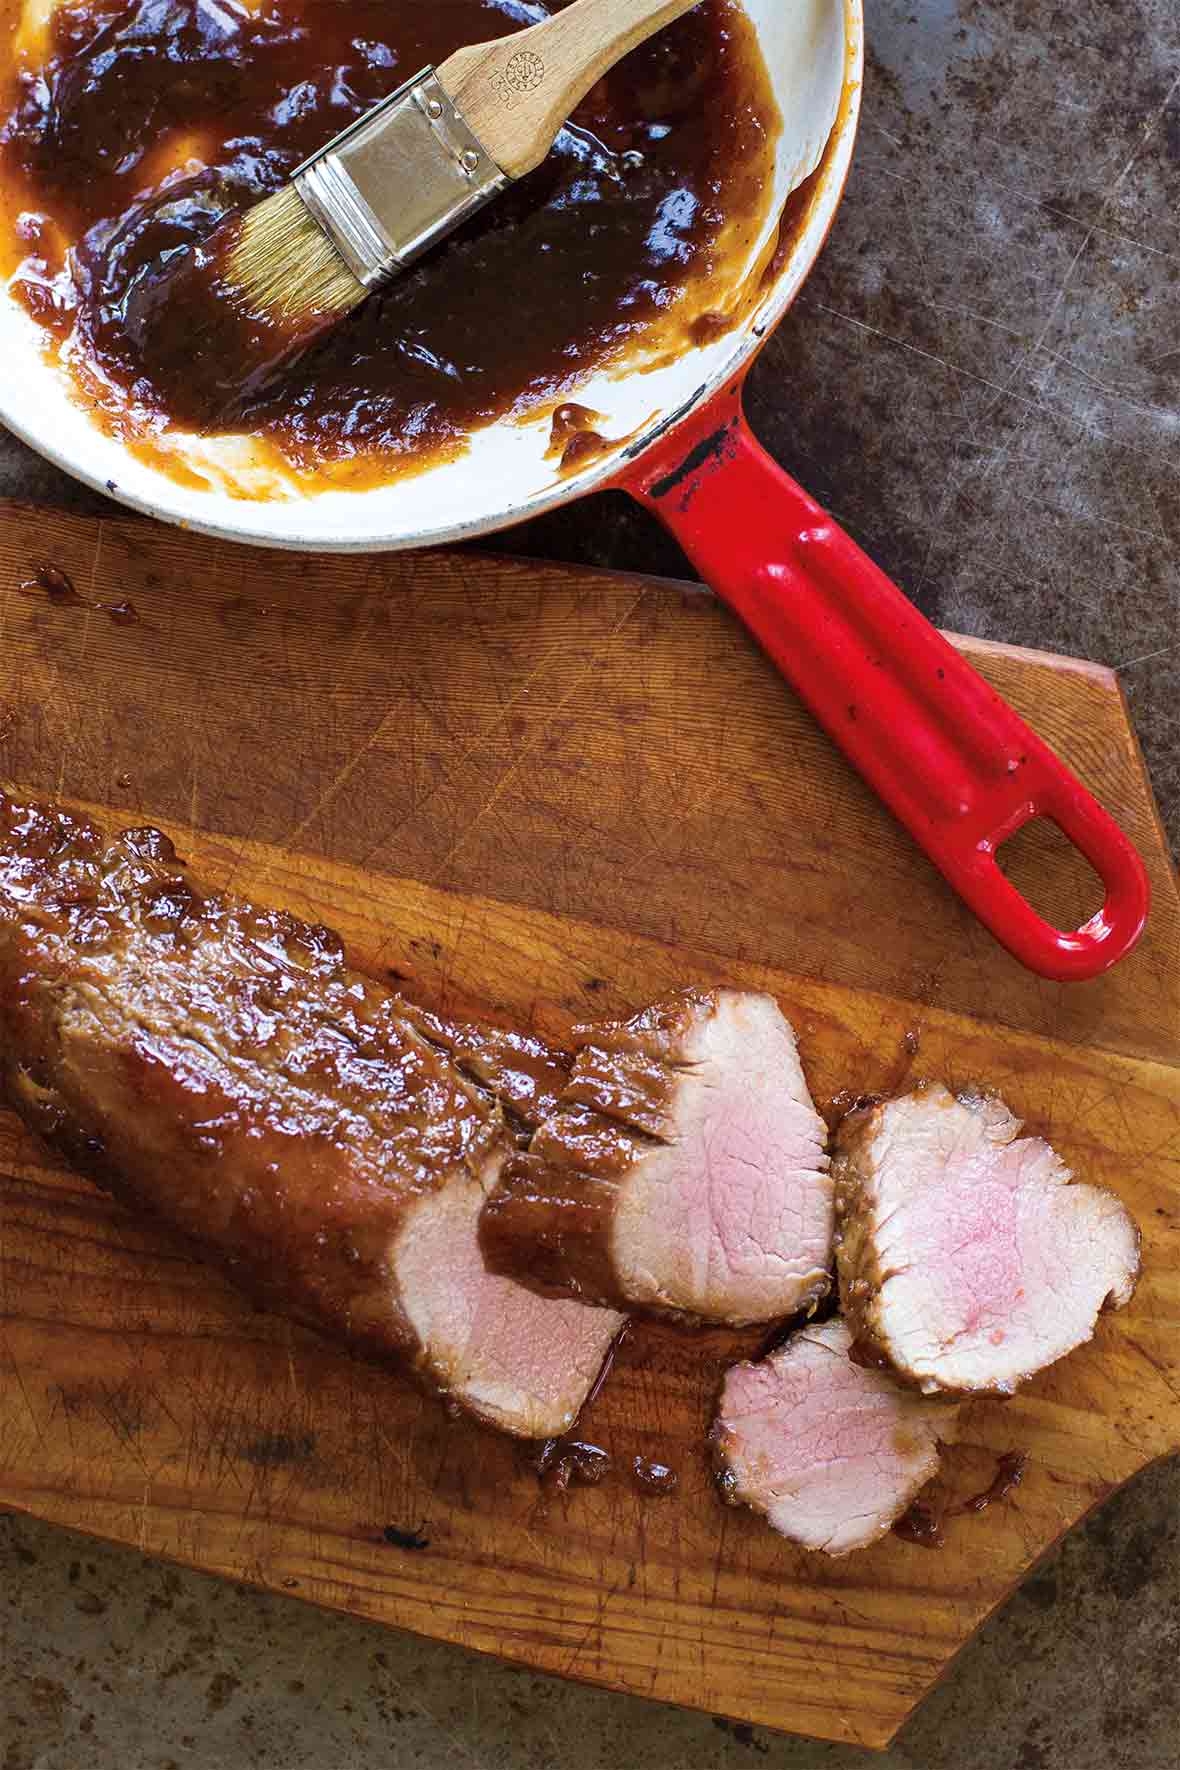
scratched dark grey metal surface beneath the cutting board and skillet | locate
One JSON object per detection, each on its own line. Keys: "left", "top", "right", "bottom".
{"left": 0, "top": 0, "right": 1180, "bottom": 1770}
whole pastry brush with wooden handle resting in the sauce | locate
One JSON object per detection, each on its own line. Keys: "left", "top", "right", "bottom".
{"left": 209, "top": 0, "right": 699, "bottom": 347}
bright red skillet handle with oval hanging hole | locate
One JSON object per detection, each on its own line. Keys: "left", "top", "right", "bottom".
{"left": 623, "top": 386, "right": 1150, "bottom": 981}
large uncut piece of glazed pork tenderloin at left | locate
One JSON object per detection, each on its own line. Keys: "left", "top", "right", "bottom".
{"left": 0, "top": 795, "right": 621, "bottom": 1437}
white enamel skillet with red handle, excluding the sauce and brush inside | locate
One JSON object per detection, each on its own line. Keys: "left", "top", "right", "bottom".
{"left": 0, "top": 0, "right": 1148, "bottom": 981}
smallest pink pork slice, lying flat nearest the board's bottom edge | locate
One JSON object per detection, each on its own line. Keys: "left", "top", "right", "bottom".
{"left": 713, "top": 1320, "right": 955, "bottom": 1556}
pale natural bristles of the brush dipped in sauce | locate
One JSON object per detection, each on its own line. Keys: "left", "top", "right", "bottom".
{"left": 225, "top": 184, "right": 366, "bottom": 333}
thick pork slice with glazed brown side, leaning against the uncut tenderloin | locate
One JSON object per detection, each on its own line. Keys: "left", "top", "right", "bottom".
{"left": 479, "top": 989, "right": 833, "bottom": 1326}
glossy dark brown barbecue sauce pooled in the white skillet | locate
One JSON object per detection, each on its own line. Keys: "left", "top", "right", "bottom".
{"left": 0, "top": 0, "right": 778, "bottom": 487}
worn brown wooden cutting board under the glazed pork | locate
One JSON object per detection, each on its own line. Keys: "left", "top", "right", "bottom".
{"left": 0, "top": 508, "right": 1180, "bottom": 1745}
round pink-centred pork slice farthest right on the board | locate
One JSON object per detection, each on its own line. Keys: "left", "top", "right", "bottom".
{"left": 835, "top": 1085, "right": 1139, "bottom": 1395}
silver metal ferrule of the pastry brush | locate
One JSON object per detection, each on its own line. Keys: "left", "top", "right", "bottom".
{"left": 292, "top": 67, "right": 511, "bottom": 289}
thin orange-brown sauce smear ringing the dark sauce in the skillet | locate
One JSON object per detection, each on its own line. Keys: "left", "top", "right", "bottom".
{"left": 0, "top": 0, "right": 782, "bottom": 497}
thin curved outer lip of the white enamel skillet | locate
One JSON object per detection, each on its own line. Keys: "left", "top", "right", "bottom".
{"left": 0, "top": 0, "right": 865, "bottom": 554}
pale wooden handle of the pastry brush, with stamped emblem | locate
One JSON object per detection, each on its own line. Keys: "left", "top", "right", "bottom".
{"left": 439, "top": 0, "right": 699, "bottom": 179}
